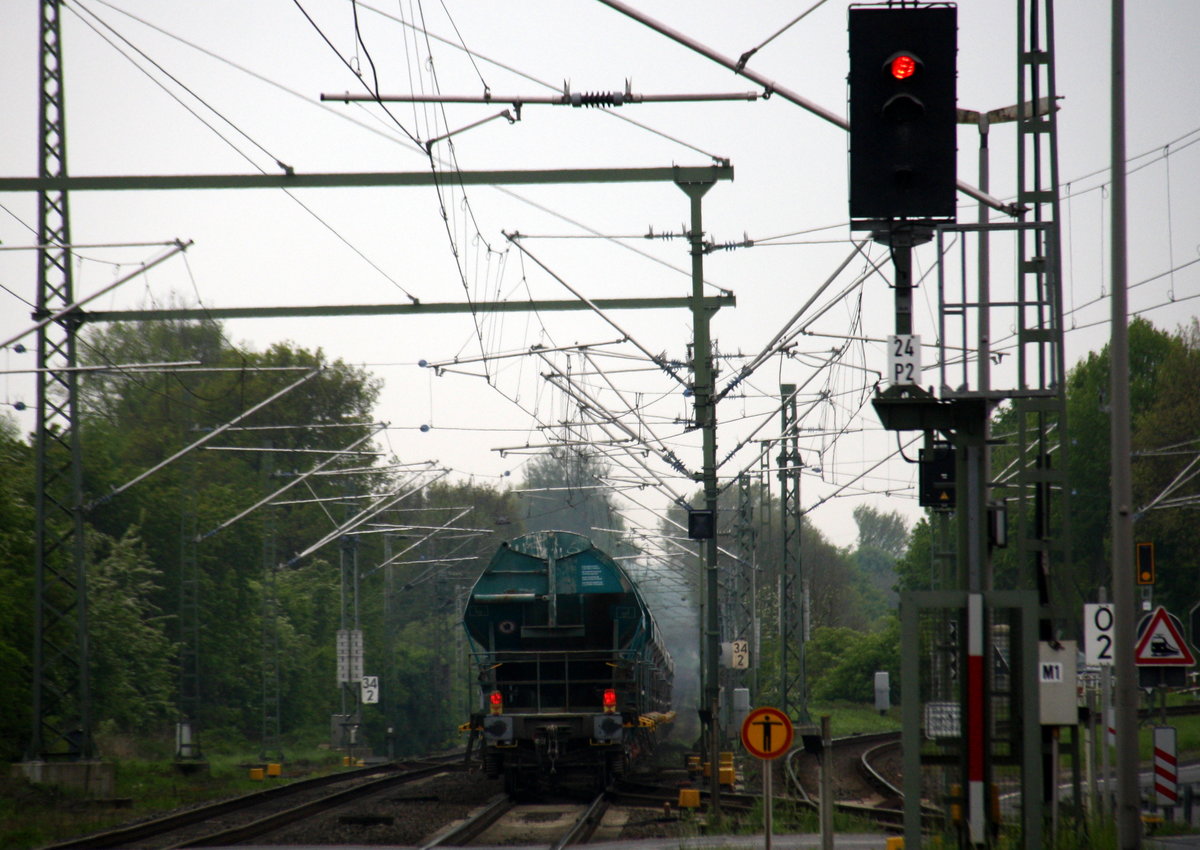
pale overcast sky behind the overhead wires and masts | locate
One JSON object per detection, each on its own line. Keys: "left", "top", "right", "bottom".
{"left": 0, "top": 0, "right": 1200, "bottom": 544}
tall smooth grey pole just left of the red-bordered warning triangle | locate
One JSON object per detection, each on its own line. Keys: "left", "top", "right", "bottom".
{"left": 1109, "top": 0, "right": 1141, "bottom": 850}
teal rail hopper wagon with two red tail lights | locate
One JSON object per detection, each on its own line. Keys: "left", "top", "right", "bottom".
{"left": 463, "top": 531, "right": 674, "bottom": 794}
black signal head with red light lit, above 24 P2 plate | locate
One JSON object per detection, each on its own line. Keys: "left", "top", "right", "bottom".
{"left": 848, "top": 5, "right": 958, "bottom": 222}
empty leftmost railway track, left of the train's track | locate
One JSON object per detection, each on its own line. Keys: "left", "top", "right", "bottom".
{"left": 43, "top": 754, "right": 462, "bottom": 850}
